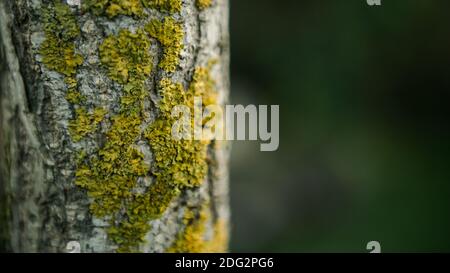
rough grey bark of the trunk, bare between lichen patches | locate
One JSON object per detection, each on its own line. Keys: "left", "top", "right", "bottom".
{"left": 0, "top": 0, "right": 229, "bottom": 252}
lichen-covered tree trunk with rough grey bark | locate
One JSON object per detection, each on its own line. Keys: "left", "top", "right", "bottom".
{"left": 0, "top": 0, "right": 229, "bottom": 252}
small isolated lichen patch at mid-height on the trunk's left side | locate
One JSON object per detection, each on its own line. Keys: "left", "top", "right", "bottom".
{"left": 69, "top": 108, "right": 106, "bottom": 142}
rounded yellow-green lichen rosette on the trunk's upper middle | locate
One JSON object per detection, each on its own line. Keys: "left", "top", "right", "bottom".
{"left": 100, "top": 30, "right": 152, "bottom": 84}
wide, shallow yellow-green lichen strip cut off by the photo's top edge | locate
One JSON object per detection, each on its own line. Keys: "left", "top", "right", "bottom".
{"left": 83, "top": 0, "right": 144, "bottom": 18}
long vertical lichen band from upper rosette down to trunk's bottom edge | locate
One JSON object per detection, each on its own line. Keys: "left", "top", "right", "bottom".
{"left": 76, "top": 27, "right": 156, "bottom": 252}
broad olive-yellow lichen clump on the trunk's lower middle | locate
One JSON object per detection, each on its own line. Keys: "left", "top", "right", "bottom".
{"left": 76, "top": 111, "right": 148, "bottom": 217}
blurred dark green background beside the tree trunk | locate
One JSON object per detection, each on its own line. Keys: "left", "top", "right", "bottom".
{"left": 231, "top": 0, "right": 450, "bottom": 252}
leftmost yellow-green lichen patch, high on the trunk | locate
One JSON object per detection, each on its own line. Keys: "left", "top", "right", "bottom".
{"left": 39, "top": 1, "right": 83, "bottom": 76}
